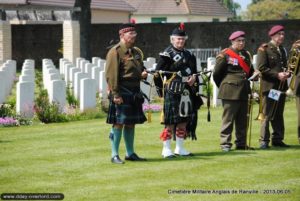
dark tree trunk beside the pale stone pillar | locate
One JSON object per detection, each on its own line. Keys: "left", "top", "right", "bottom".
{"left": 73, "top": 0, "right": 92, "bottom": 60}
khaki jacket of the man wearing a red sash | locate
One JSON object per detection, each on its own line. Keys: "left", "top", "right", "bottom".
{"left": 213, "top": 48, "right": 254, "bottom": 100}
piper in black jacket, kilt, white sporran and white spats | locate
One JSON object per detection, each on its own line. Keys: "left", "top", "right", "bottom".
{"left": 154, "top": 24, "right": 199, "bottom": 158}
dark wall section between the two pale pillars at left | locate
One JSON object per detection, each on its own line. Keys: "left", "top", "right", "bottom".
{"left": 11, "top": 24, "right": 63, "bottom": 69}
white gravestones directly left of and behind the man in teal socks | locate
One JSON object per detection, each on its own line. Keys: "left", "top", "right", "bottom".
{"left": 59, "top": 57, "right": 156, "bottom": 111}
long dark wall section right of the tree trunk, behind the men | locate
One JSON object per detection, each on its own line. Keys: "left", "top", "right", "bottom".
{"left": 92, "top": 20, "right": 300, "bottom": 58}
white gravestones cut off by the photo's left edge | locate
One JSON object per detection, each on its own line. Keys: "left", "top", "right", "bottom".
{"left": 0, "top": 60, "right": 17, "bottom": 104}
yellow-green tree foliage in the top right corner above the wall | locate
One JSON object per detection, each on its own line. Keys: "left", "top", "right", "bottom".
{"left": 243, "top": 0, "right": 300, "bottom": 20}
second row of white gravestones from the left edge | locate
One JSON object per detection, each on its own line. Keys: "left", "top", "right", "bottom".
{"left": 16, "top": 59, "right": 35, "bottom": 118}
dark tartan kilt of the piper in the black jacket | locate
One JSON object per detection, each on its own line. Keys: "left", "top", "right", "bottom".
{"left": 164, "top": 90, "right": 189, "bottom": 125}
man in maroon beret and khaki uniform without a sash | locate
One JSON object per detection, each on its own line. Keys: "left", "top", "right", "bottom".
{"left": 257, "top": 25, "right": 290, "bottom": 149}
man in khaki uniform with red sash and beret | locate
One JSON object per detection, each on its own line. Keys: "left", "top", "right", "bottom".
{"left": 213, "top": 31, "right": 254, "bottom": 152}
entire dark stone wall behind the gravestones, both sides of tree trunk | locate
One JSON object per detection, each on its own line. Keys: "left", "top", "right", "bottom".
{"left": 12, "top": 20, "right": 300, "bottom": 68}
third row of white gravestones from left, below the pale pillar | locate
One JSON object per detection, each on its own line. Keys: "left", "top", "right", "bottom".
{"left": 42, "top": 59, "right": 66, "bottom": 112}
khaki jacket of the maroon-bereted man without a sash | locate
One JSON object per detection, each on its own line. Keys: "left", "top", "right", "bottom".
{"left": 257, "top": 42, "right": 288, "bottom": 93}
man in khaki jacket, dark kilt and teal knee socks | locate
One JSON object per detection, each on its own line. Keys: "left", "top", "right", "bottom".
{"left": 105, "top": 23, "right": 147, "bottom": 164}
